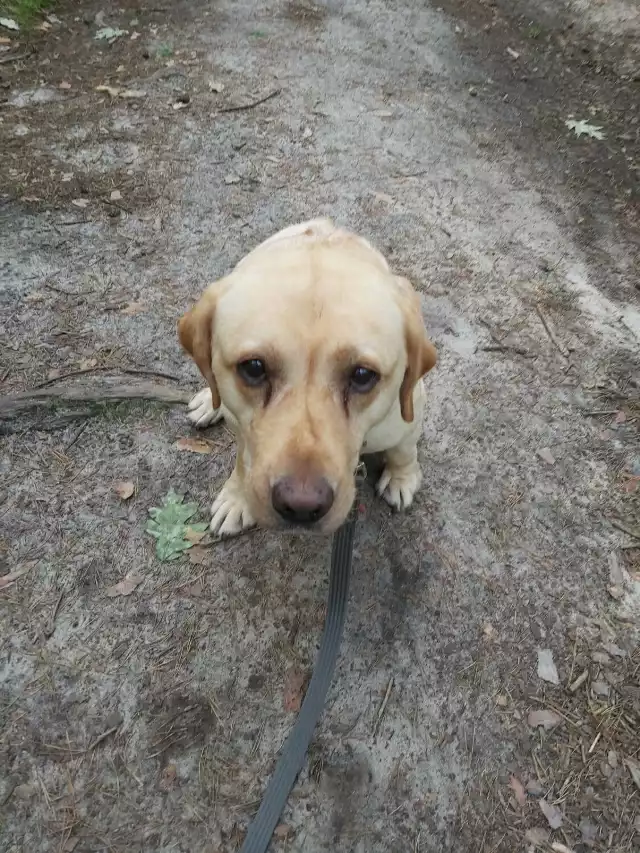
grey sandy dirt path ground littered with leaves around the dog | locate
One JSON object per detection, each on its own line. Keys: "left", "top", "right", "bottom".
{"left": 0, "top": 0, "right": 640, "bottom": 853}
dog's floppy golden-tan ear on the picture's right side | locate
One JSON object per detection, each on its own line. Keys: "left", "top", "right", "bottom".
{"left": 396, "top": 276, "right": 438, "bottom": 423}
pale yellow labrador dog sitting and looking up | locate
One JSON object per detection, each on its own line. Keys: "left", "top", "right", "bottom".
{"left": 179, "top": 219, "right": 436, "bottom": 535}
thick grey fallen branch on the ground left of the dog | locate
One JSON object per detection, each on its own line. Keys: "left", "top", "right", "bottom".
{"left": 0, "top": 382, "right": 192, "bottom": 418}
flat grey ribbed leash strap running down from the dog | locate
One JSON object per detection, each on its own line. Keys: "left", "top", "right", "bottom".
{"left": 240, "top": 509, "right": 356, "bottom": 853}
